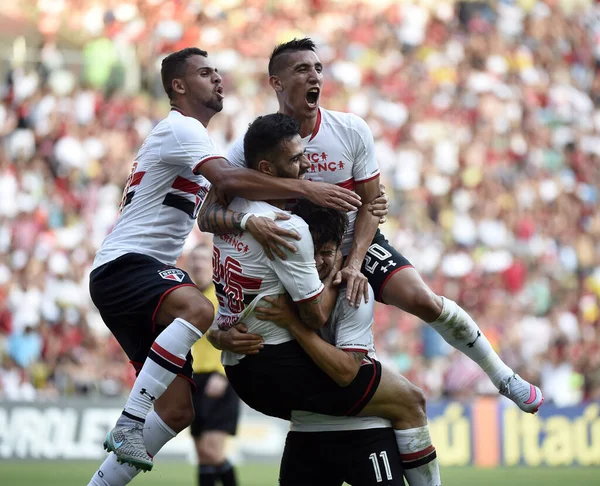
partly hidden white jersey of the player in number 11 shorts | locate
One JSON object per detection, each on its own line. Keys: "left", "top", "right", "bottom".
{"left": 290, "top": 286, "right": 392, "bottom": 432}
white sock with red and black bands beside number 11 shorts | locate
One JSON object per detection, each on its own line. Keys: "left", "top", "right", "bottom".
{"left": 394, "top": 425, "right": 442, "bottom": 486}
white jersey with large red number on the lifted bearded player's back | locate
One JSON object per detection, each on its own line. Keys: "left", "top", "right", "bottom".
{"left": 213, "top": 198, "right": 324, "bottom": 365}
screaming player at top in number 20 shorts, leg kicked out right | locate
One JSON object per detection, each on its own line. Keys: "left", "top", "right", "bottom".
{"left": 223, "top": 38, "right": 543, "bottom": 413}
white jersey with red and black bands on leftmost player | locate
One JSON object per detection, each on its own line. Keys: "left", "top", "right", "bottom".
{"left": 94, "top": 110, "right": 222, "bottom": 268}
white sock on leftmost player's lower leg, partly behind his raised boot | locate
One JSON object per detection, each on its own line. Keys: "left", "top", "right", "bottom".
{"left": 88, "top": 411, "right": 177, "bottom": 486}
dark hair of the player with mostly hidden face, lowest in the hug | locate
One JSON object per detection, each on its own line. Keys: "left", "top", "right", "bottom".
{"left": 293, "top": 199, "right": 348, "bottom": 248}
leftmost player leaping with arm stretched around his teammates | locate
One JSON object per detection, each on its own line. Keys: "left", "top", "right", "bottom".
{"left": 90, "top": 48, "right": 360, "bottom": 485}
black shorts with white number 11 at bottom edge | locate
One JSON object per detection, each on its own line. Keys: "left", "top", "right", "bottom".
{"left": 279, "top": 428, "right": 404, "bottom": 486}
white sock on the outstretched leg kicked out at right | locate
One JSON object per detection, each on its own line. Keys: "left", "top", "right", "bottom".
{"left": 429, "top": 297, "right": 514, "bottom": 388}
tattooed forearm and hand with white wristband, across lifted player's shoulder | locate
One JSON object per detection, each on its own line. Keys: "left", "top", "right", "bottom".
{"left": 198, "top": 186, "right": 300, "bottom": 260}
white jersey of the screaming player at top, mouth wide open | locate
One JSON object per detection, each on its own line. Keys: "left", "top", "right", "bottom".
{"left": 227, "top": 108, "right": 379, "bottom": 256}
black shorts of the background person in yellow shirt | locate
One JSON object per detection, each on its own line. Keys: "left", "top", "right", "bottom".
{"left": 191, "top": 373, "right": 240, "bottom": 437}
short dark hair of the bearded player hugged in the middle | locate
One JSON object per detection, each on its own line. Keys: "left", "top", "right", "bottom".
{"left": 244, "top": 113, "right": 300, "bottom": 169}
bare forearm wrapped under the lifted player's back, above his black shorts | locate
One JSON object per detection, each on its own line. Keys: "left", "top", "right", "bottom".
{"left": 255, "top": 294, "right": 366, "bottom": 387}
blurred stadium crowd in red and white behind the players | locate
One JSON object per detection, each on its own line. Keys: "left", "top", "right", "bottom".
{"left": 0, "top": 0, "right": 600, "bottom": 405}
